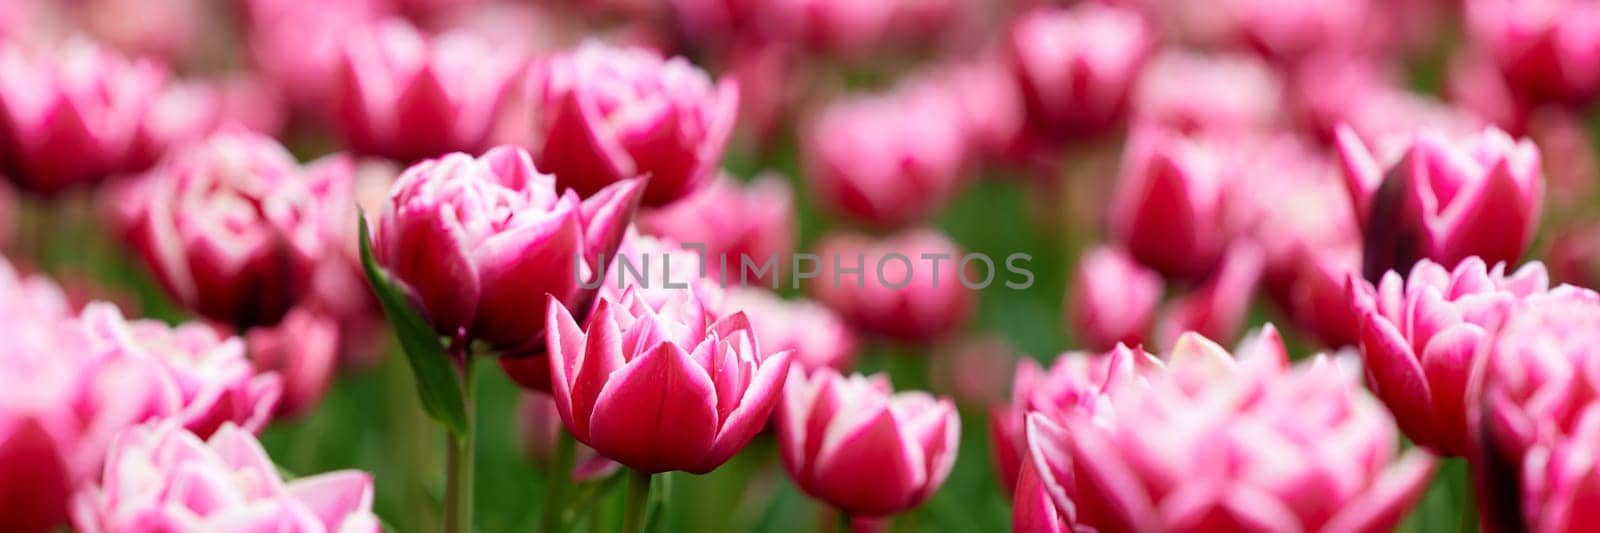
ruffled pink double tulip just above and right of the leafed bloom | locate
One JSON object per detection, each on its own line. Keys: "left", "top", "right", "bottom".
{"left": 533, "top": 42, "right": 739, "bottom": 205}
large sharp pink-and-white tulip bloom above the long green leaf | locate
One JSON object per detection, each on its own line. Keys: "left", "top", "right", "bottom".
{"left": 373, "top": 146, "right": 642, "bottom": 355}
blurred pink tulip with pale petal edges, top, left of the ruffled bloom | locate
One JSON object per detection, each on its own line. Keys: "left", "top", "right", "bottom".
{"left": 336, "top": 21, "right": 523, "bottom": 163}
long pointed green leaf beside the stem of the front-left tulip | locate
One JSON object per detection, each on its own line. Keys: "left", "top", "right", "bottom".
{"left": 358, "top": 213, "right": 467, "bottom": 439}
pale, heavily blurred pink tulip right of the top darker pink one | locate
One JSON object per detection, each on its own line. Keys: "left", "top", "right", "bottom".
{"left": 1133, "top": 51, "right": 1283, "bottom": 136}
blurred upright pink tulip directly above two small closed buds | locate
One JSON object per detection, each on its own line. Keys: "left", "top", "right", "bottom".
{"left": 1110, "top": 130, "right": 1230, "bottom": 280}
